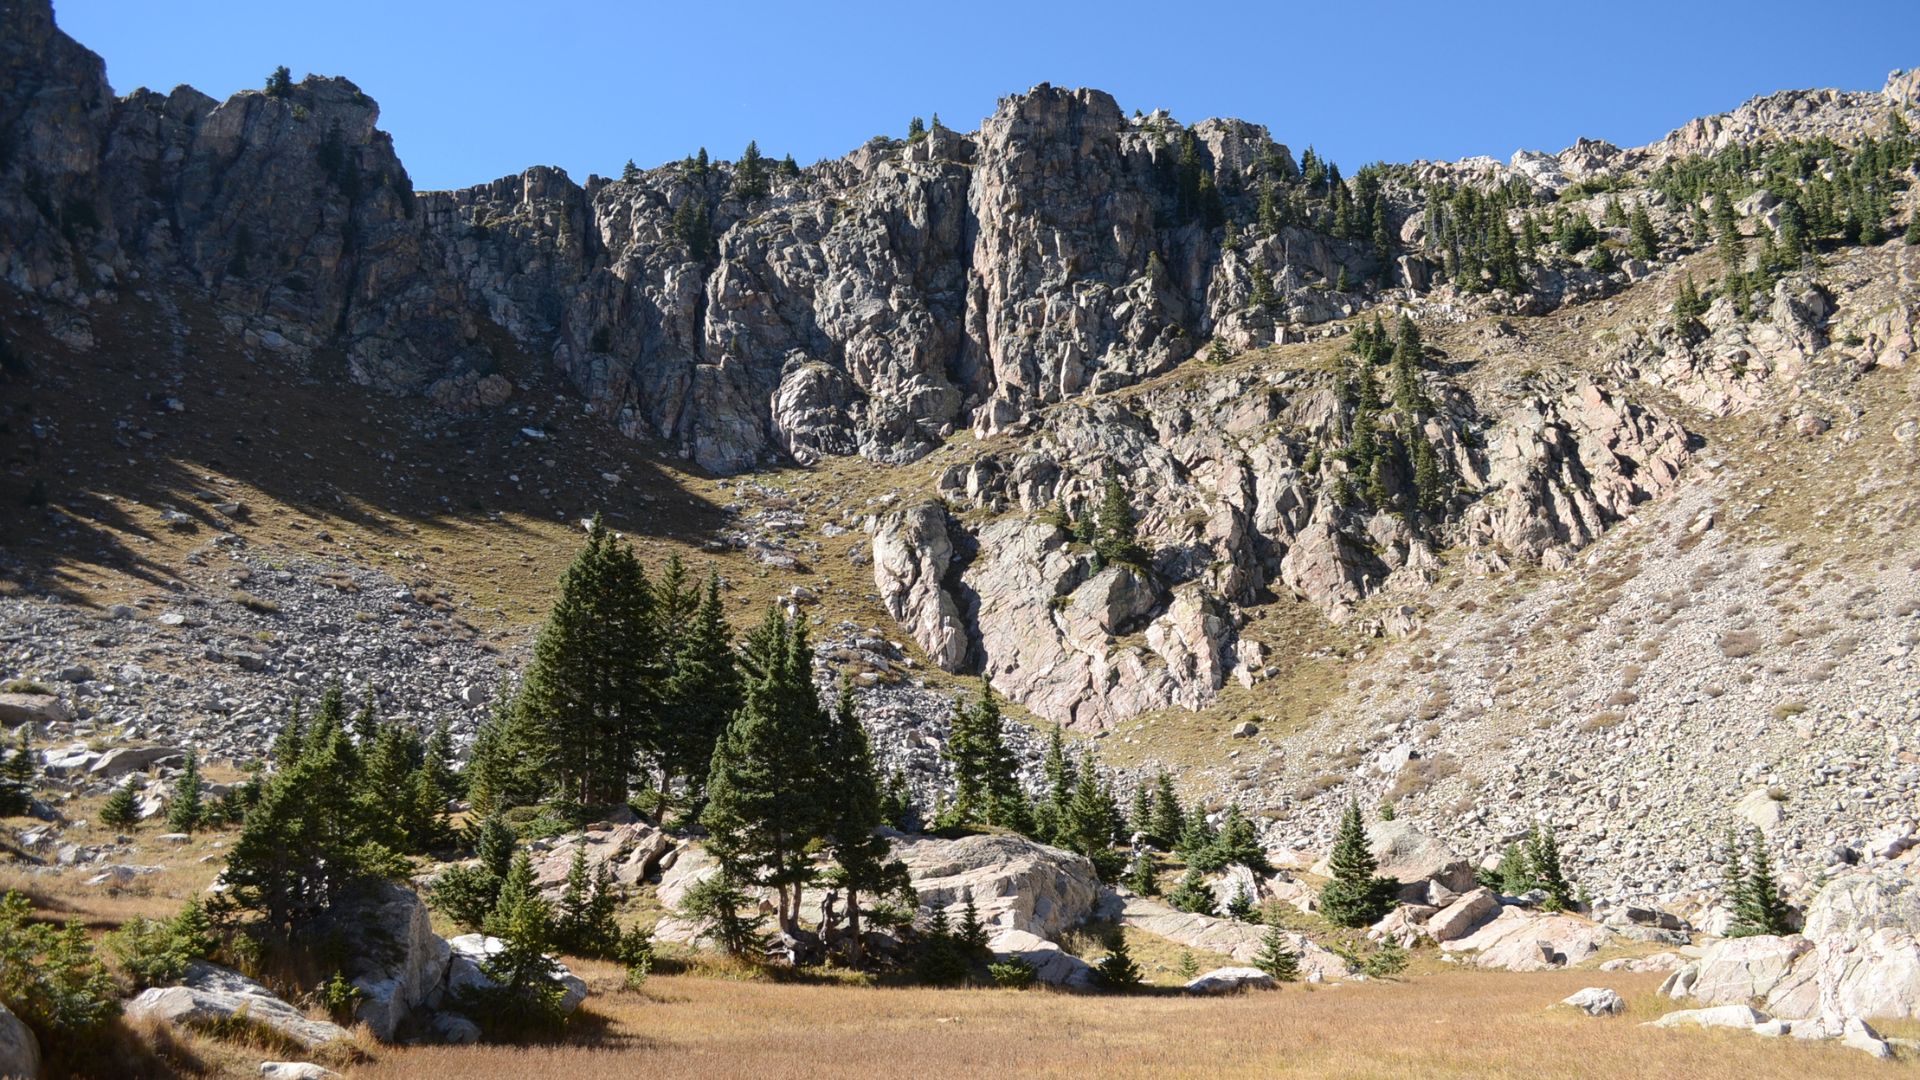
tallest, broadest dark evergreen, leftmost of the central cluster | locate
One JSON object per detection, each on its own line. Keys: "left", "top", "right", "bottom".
{"left": 515, "top": 517, "right": 659, "bottom": 807}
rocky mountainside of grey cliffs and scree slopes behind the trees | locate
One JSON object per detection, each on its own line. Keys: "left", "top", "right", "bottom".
{"left": 0, "top": 0, "right": 1920, "bottom": 1074}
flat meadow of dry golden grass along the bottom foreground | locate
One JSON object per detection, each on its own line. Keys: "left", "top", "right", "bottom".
{"left": 351, "top": 970, "right": 1878, "bottom": 1080}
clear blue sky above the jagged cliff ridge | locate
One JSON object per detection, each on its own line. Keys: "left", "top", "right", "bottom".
{"left": 56, "top": 0, "right": 1920, "bottom": 188}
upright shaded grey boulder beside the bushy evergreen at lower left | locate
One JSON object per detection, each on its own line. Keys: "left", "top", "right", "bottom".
{"left": 340, "top": 884, "right": 449, "bottom": 1042}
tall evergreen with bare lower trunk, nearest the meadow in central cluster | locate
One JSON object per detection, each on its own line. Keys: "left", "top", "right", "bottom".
{"left": 701, "top": 607, "right": 831, "bottom": 934}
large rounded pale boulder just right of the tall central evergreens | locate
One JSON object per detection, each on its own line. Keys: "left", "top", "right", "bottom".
{"left": 893, "top": 836, "right": 1100, "bottom": 940}
